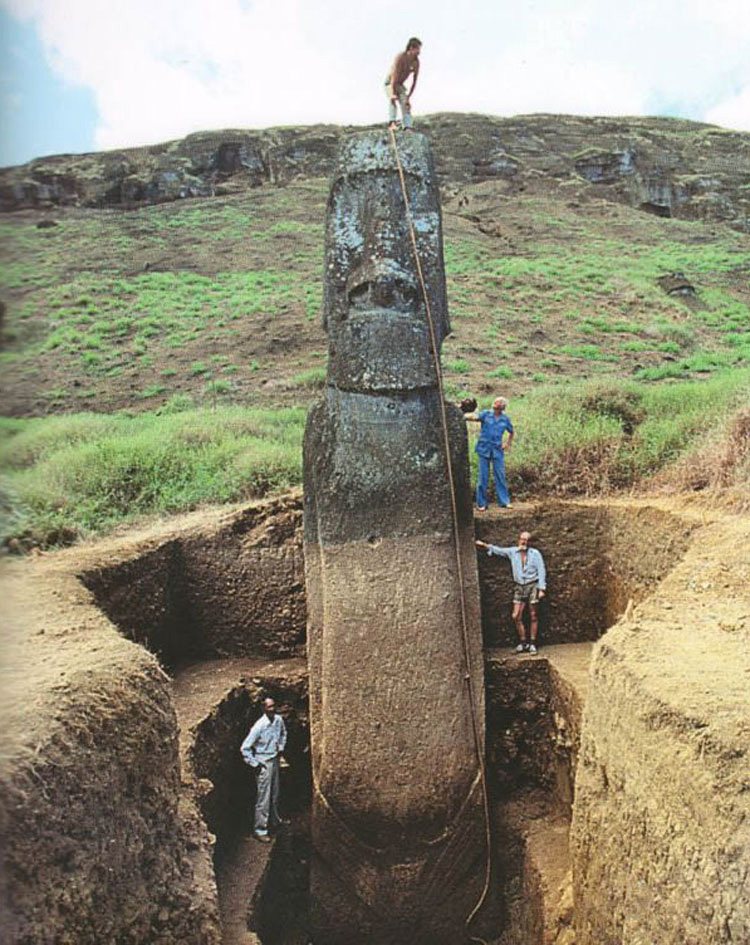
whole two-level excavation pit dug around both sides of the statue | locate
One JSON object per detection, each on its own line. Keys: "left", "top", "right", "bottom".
{"left": 1, "top": 497, "right": 695, "bottom": 945}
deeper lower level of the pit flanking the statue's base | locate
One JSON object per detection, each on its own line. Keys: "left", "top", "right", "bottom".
{"left": 164, "top": 643, "right": 590, "bottom": 945}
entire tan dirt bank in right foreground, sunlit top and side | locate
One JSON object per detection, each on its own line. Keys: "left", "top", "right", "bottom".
{"left": 572, "top": 508, "right": 750, "bottom": 945}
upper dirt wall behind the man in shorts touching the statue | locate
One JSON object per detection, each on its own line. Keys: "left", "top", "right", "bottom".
{"left": 475, "top": 501, "right": 695, "bottom": 646}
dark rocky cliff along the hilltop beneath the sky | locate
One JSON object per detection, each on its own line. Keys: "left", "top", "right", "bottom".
{"left": 0, "top": 114, "right": 750, "bottom": 232}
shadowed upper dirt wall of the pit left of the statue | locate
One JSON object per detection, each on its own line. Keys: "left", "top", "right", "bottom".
{"left": 80, "top": 496, "right": 306, "bottom": 667}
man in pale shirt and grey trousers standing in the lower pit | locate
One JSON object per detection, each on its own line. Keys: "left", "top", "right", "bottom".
{"left": 240, "top": 698, "right": 286, "bottom": 843}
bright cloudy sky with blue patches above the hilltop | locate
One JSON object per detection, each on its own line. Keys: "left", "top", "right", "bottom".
{"left": 0, "top": 0, "right": 750, "bottom": 165}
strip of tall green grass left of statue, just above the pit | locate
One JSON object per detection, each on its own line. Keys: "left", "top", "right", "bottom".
{"left": 0, "top": 402, "right": 305, "bottom": 544}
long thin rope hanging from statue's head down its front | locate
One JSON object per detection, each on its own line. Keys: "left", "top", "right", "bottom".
{"left": 389, "top": 127, "right": 492, "bottom": 941}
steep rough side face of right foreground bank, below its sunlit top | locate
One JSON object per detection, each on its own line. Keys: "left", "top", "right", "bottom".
{"left": 572, "top": 628, "right": 750, "bottom": 945}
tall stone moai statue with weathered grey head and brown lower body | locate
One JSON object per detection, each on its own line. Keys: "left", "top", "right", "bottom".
{"left": 304, "top": 132, "right": 486, "bottom": 945}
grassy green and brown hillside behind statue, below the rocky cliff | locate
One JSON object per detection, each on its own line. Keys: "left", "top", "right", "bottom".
{"left": 0, "top": 116, "right": 750, "bottom": 540}
